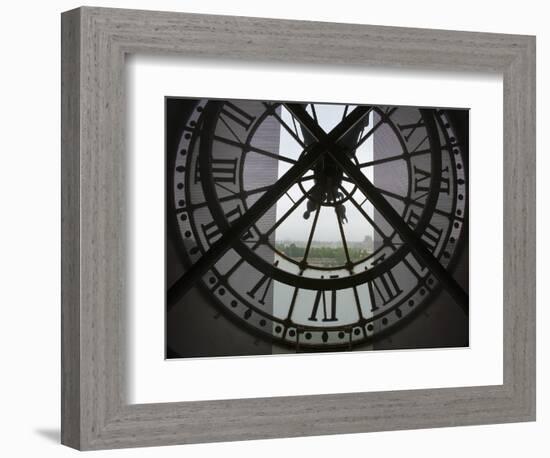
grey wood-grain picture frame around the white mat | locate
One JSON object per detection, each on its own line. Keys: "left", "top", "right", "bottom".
{"left": 61, "top": 7, "right": 535, "bottom": 450}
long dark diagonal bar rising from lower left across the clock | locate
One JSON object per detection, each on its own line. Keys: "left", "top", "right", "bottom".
{"left": 167, "top": 102, "right": 370, "bottom": 307}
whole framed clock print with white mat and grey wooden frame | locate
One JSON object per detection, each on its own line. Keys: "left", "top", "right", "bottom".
{"left": 62, "top": 7, "right": 535, "bottom": 450}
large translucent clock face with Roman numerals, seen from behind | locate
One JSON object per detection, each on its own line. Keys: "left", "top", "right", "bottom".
{"left": 166, "top": 99, "right": 468, "bottom": 356}
